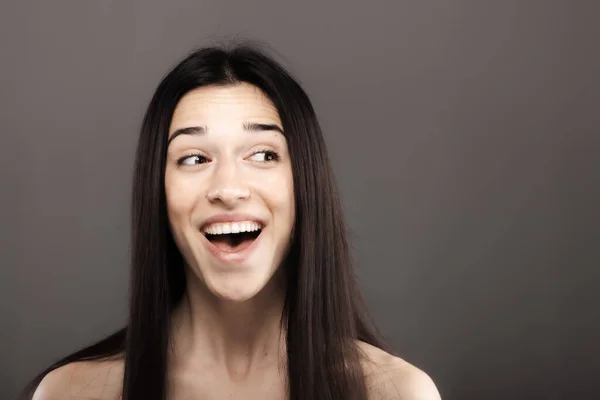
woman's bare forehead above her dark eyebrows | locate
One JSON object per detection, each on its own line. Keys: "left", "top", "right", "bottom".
{"left": 169, "top": 83, "right": 281, "bottom": 135}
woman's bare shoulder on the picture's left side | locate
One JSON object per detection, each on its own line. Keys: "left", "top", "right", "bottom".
{"left": 32, "top": 359, "right": 124, "bottom": 400}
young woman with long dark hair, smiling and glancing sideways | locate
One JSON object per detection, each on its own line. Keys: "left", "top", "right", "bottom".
{"left": 23, "top": 42, "right": 439, "bottom": 400}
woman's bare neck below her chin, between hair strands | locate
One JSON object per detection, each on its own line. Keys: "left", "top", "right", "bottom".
{"left": 172, "top": 268, "right": 285, "bottom": 379}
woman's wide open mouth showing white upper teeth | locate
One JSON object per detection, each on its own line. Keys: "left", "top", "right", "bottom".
{"left": 204, "top": 224, "right": 262, "bottom": 253}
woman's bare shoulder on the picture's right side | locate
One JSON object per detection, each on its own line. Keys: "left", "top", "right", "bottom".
{"left": 358, "top": 342, "right": 440, "bottom": 400}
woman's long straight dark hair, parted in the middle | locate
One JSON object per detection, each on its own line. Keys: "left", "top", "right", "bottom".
{"left": 17, "top": 44, "right": 385, "bottom": 400}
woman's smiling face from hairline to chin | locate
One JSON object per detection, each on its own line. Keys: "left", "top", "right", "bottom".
{"left": 165, "top": 83, "right": 295, "bottom": 301}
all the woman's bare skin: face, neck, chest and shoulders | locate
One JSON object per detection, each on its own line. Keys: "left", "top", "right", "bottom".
{"left": 34, "top": 84, "right": 439, "bottom": 400}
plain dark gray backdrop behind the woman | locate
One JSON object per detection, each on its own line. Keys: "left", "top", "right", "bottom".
{"left": 0, "top": 0, "right": 600, "bottom": 399}
